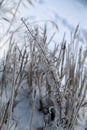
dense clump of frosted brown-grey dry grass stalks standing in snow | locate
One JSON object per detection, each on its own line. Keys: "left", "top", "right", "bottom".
{"left": 0, "top": 20, "right": 87, "bottom": 130}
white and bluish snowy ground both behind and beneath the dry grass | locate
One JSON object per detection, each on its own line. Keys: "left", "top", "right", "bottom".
{"left": 0, "top": 0, "right": 87, "bottom": 130}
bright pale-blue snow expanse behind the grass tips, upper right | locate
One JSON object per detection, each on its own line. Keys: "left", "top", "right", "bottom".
{"left": 18, "top": 0, "right": 87, "bottom": 39}
